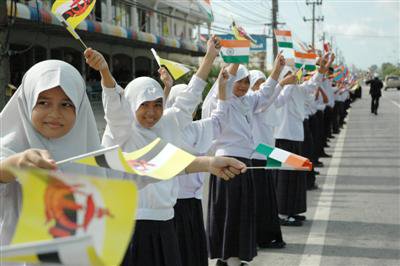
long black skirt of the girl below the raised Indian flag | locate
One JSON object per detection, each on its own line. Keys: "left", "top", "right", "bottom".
{"left": 207, "top": 157, "right": 257, "bottom": 261}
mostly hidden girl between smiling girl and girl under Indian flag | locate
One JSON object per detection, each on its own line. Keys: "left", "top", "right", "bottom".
{"left": 162, "top": 68, "right": 229, "bottom": 266}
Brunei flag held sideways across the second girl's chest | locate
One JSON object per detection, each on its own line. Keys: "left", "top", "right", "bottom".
{"left": 57, "top": 138, "right": 195, "bottom": 180}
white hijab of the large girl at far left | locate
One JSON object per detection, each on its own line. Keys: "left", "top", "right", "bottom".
{"left": 0, "top": 60, "right": 104, "bottom": 245}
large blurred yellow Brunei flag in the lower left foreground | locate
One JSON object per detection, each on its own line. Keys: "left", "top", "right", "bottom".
{"left": 0, "top": 168, "right": 138, "bottom": 265}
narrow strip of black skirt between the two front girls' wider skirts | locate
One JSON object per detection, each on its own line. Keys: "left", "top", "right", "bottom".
{"left": 174, "top": 198, "right": 208, "bottom": 266}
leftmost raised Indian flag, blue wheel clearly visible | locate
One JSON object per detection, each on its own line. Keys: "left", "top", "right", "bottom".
{"left": 220, "top": 40, "right": 250, "bottom": 63}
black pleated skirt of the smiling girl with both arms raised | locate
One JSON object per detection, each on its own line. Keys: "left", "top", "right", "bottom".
{"left": 121, "top": 219, "right": 183, "bottom": 266}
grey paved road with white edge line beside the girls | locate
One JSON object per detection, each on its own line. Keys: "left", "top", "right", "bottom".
{"left": 205, "top": 88, "right": 400, "bottom": 266}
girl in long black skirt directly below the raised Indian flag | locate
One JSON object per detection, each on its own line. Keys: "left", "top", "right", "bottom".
{"left": 202, "top": 55, "right": 285, "bottom": 265}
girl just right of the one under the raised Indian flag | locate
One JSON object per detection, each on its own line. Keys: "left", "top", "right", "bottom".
{"left": 248, "top": 70, "right": 286, "bottom": 248}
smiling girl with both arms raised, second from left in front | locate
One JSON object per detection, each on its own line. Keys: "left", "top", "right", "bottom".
{"left": 85, "top": 40, "right": 244, "bottom": 266}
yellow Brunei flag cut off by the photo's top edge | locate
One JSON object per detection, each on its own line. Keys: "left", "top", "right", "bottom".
{"left": 51, "top": 0, "right": 96, "bottom": 39}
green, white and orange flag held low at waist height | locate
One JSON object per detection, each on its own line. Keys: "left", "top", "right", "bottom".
{"left": 256, "top": 144, "right": 312, "bottom": 171}
